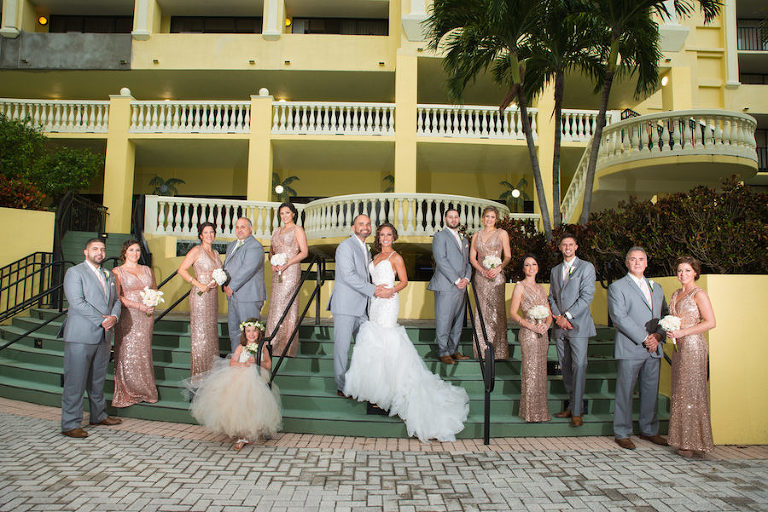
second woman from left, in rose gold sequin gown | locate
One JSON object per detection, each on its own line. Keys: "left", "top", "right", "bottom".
{"left": 179, "top": 222, "right": 221, "bottom": 377}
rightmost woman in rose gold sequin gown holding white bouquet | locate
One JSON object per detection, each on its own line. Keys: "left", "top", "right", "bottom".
{"left": 667, "top": 257, "right": 715, "bottom": 457}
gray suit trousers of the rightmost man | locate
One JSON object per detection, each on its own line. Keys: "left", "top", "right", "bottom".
{"left": 613, "top": 357, "right": 661, "bottom": 439}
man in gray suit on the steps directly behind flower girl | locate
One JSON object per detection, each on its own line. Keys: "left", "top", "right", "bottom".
{"left": 223, "top": 217, "right": 267, "bottom": 352}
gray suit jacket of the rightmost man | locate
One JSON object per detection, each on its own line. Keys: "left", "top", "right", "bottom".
{"left": 608, "top": 274, "right": 667, "bottom": 359}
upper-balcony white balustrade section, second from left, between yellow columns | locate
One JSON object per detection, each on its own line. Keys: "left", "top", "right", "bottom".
{"left": 130, "top": 101, "right": 251, "bottom": 133}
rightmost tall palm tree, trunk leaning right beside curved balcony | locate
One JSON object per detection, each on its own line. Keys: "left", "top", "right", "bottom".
{"left": 576, "top": 0, "right": 720, "bottom": 224}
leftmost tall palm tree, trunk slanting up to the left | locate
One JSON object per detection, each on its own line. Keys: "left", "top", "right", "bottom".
{"left": 425, "top": 0, "right": 552, "bottom": 240}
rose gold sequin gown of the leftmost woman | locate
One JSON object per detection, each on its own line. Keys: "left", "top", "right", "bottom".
{"left": 112, "top": 265, "right": 157, "bottom": 407}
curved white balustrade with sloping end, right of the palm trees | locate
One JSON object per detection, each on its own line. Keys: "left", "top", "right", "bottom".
{"left": 560, "top": 110, "right": 757, "bottom": 222}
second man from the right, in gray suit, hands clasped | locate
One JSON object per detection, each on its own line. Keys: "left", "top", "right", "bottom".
{"left": 549, "top": 233, "right": 597, "bottom": 427}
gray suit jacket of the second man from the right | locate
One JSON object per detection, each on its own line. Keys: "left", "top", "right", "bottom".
{"left": 549, "top": 257, "right": 597, "bottom": 338}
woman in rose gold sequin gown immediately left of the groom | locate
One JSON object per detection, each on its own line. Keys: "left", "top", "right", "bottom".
{"left": 265, "top": 203, "right": 309, "bottom": 357}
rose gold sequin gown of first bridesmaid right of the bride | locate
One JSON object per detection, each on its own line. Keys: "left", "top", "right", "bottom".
{"left": 472, "top": 229, "right": 509, "bottom": 359}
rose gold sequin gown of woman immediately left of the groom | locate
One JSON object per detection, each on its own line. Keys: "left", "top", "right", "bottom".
{"left": 266, "top": 228, "right": 301, "bottom": 357}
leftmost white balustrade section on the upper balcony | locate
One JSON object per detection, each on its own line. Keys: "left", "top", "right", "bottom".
{"left": 0, "top": 98, "right": 109, "bottom": 133}
